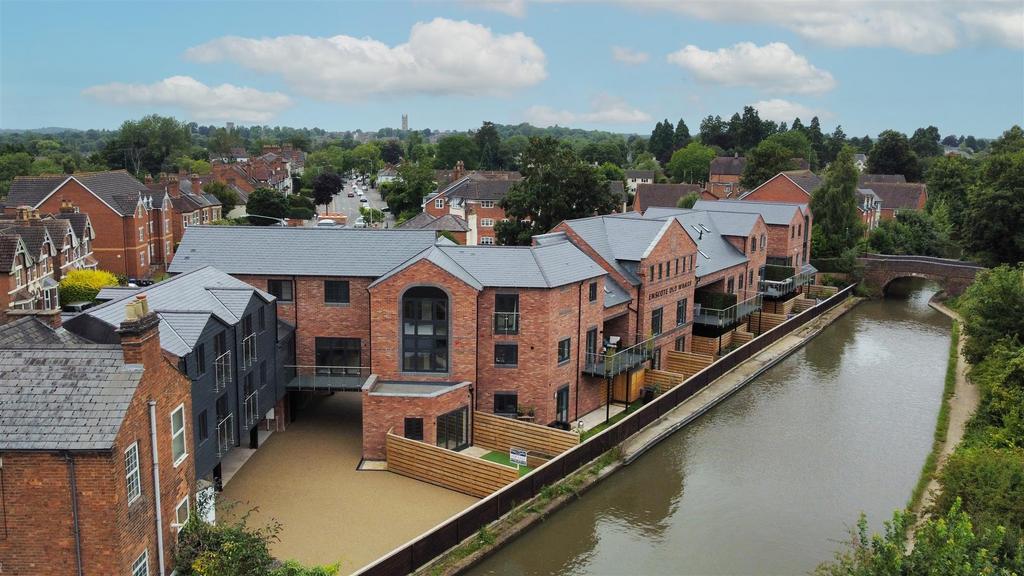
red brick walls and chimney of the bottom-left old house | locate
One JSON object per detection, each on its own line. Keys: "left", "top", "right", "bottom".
{"left": 0, "top": 317, "right": 195, "bottom": 575}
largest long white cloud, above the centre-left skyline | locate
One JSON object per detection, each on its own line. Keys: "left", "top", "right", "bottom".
{"left": 185, "top": 18, "right": 547, "bottom": 101}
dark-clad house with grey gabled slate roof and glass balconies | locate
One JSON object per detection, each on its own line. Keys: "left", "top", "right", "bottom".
{"left": 65, "top": 268, "right": 282, "bottom": 487}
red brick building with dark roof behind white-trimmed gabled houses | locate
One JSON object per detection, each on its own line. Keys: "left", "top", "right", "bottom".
{"left": 4, "top": 170, "right": 174, "bottom": 278}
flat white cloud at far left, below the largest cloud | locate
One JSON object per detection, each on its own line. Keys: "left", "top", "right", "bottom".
{"left": 82, "top": 76, "right": 292, "bottom": 122}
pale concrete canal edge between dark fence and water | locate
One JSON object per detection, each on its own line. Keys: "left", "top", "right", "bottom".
{"left": 414, "top": 297, "right": 863, "bottom": 576}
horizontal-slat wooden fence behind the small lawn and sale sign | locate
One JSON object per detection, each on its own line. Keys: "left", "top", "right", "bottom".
{"left": 473, "top": 412, "right": 580, "bottom": 456}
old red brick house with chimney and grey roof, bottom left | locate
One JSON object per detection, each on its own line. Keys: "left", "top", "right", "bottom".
{"left": 0, "top": 295, "right": 195, "bottom": 576}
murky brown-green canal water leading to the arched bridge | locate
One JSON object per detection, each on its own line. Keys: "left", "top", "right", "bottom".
{"left": 470, "top": 279, "right": 950, "bottom": 575}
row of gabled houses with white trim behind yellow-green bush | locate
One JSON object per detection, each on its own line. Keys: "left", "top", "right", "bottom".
{"left": 0, "top": 208, "right": 96, "bottom": 324}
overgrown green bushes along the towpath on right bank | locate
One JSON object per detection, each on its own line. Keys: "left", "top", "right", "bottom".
{"left": 817, "top": 265, "right": 1024, "bottom": 576}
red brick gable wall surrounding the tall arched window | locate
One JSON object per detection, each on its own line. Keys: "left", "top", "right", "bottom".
{"left": 370, "top": 260, "right": 477, "bottom": 382}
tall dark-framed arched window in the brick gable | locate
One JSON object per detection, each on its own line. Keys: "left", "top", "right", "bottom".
{"left": 401, "top": 286, "right": 449, "bottom": 372}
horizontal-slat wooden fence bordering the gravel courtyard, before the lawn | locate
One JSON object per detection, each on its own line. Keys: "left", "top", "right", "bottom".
{"left": 387, "top": 430, "right": 519, "bottom": 498}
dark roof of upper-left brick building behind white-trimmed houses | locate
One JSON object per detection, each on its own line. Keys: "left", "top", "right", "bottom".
{"left": 6, "top": 170, "right": 163, "bottom": 215}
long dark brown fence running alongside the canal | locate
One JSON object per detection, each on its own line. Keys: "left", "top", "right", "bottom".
{"left": 357, "top": 285, "right": 854, "bottom": 576}
